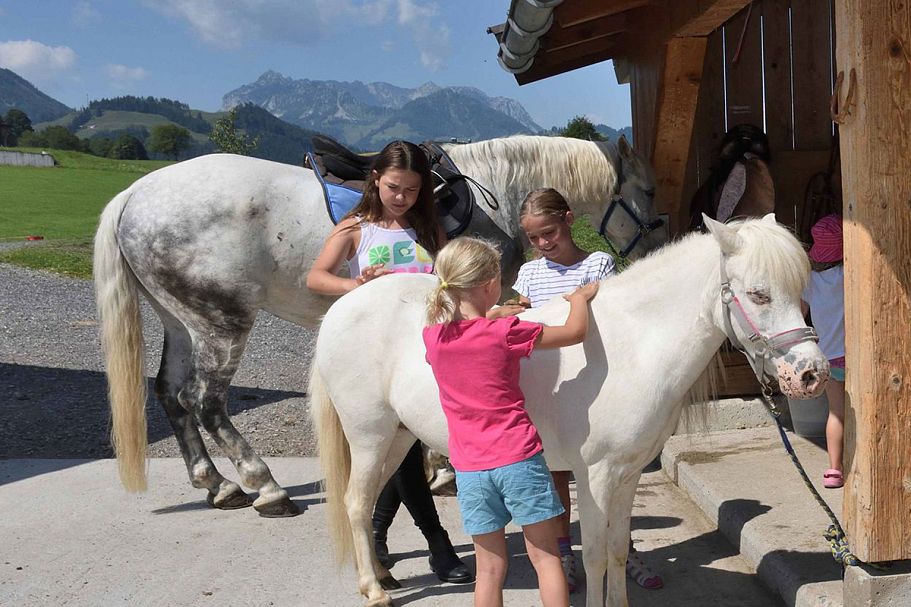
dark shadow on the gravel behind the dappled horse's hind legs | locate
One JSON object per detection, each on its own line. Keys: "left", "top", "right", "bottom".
{"left": 0, "top": 363, "right": 304, "bottom": 484}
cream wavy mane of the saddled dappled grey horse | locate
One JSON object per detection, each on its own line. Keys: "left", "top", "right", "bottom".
{"left": 443, "top": 135, "right": 617, "bottom": 206}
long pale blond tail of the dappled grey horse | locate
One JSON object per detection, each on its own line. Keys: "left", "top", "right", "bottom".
{"left": 93, "top": 190, "right": 147, "bottom": 491}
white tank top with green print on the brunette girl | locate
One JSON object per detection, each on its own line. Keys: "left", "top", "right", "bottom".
{"left": 348, "top": 222, "right": 433, "bottom": 277}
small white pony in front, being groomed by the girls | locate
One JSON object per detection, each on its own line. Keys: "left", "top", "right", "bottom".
{"left": 310, "top": 215, "right": 829, "bottom": 607}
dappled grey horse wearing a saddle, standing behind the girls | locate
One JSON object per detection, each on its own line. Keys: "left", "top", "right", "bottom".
{"left": 94, "top": 137, "right": 656, "bottom": 516}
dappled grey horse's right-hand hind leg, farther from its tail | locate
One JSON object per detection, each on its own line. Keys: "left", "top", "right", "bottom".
{"left": 184, "top": 322, "right": 300, "bottom": 517}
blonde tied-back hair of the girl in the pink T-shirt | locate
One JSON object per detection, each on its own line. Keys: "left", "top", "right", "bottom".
{"left": 426, "top": 236, "right": 500, "bottom": 325}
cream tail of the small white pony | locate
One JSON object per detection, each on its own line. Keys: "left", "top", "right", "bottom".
{"left": 309, "top": 361, "right": 354, "bottom": 566}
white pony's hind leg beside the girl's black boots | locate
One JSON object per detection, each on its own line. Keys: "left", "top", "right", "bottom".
{"left": 345, "top": 430, "right": 416, "bottom": 607}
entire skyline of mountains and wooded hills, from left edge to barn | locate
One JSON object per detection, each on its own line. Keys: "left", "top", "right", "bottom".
{"left": 0, "top": 68, "right": 631, "bottom": 164}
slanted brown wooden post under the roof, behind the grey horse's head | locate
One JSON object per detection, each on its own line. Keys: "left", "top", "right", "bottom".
{"left": 652, "top": 37, "right": 706, "bottom": 236}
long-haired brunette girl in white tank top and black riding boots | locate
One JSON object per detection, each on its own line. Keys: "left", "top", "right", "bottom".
{"left": 307, "top": 141, "right": 474, "bottom": 584}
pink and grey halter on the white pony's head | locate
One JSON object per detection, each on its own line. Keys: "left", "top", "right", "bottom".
{"left": 721, "top": 255, "right": 819, "bottom": 396}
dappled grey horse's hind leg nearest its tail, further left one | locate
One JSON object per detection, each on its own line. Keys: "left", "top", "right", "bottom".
{"left": 155, "top": 320, "right": 253, "bottom": 510}
